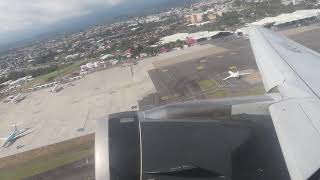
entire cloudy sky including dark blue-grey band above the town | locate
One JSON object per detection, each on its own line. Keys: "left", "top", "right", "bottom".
{"left": 0, "top": 0, "right": 190, "bottom": 47}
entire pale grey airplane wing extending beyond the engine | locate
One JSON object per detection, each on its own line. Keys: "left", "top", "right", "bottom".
{"left": 249, "top": 27, "right": 320, "bottom": 180}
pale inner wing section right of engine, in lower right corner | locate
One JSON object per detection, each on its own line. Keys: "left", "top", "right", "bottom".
{"left": 269, "top": 98, "right": 320, "bottom": 180}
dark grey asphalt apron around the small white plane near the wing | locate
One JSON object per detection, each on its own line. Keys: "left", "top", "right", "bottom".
{"left": 149, "top": 36, "right": 262, "bottom": 104}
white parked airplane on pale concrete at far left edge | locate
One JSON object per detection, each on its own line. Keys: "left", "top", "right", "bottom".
{"left": 0, "top": 124, "right": 33, "bottom": 148}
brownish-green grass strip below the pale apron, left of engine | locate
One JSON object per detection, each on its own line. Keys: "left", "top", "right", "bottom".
{"left": 0, "top": 136, "right": 94, "bottom": 180}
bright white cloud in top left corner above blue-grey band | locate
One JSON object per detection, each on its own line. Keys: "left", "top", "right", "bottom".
{"left": 0, "top": 0, "right": 123, "bottom": 35}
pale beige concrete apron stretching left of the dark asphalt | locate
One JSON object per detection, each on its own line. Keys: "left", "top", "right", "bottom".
{"left": 0, "top": 45, "right": 224, "bottom": 158}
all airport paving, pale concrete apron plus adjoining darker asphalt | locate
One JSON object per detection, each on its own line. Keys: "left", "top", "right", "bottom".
{"left": 0, "top": 23, "right": 320, "bottom": 158}
